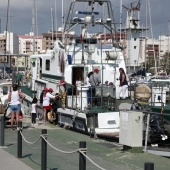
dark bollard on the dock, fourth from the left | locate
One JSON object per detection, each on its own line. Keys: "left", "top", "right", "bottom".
{"left": 79, "top": 141, "right": 86, "bottom": 170}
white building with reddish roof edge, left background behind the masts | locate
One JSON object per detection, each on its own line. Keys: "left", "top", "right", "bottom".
{"left": 18, "top": 32, "right": 42, "bottom": 55}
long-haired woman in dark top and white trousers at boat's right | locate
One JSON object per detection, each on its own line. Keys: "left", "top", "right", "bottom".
{"left": 119, "top": 68, "right": 128, "bottom": 99}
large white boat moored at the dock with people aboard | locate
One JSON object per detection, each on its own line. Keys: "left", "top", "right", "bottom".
{"left": 17, "top": 0, "right": 130, "bottom": 136}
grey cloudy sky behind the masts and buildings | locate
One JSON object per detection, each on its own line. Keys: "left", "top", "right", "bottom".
{"left": 0, "top": 0, "right": 170, "bottom": 37}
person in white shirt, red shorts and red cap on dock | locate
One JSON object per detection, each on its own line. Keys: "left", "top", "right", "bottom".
{"left": 43, "top": 88, "right": 55, "bottom": 122}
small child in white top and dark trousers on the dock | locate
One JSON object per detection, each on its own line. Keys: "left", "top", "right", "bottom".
{"left": 31, "top": 97, "right": 38, "bottom": 126}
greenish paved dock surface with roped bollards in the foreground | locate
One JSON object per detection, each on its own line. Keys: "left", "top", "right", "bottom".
{"left": 0, "top": 118, "right": 170, "bottom": 170}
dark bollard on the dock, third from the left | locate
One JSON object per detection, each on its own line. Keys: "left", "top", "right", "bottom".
{"left": 41, "top": 129, "right": 47, "bottom": 170}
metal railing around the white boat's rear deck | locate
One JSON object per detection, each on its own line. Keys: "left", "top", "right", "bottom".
{"left": 66, "top": 85, "right": 116, "bottom": 112}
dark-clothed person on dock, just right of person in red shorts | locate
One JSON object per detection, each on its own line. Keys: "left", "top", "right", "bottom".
{"left": 52, "top": 93, "right": 61, "bottom": 124}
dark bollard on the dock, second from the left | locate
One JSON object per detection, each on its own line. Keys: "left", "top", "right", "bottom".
{"left": 17, "top": 121, "right": 22, "bottom": 158}
